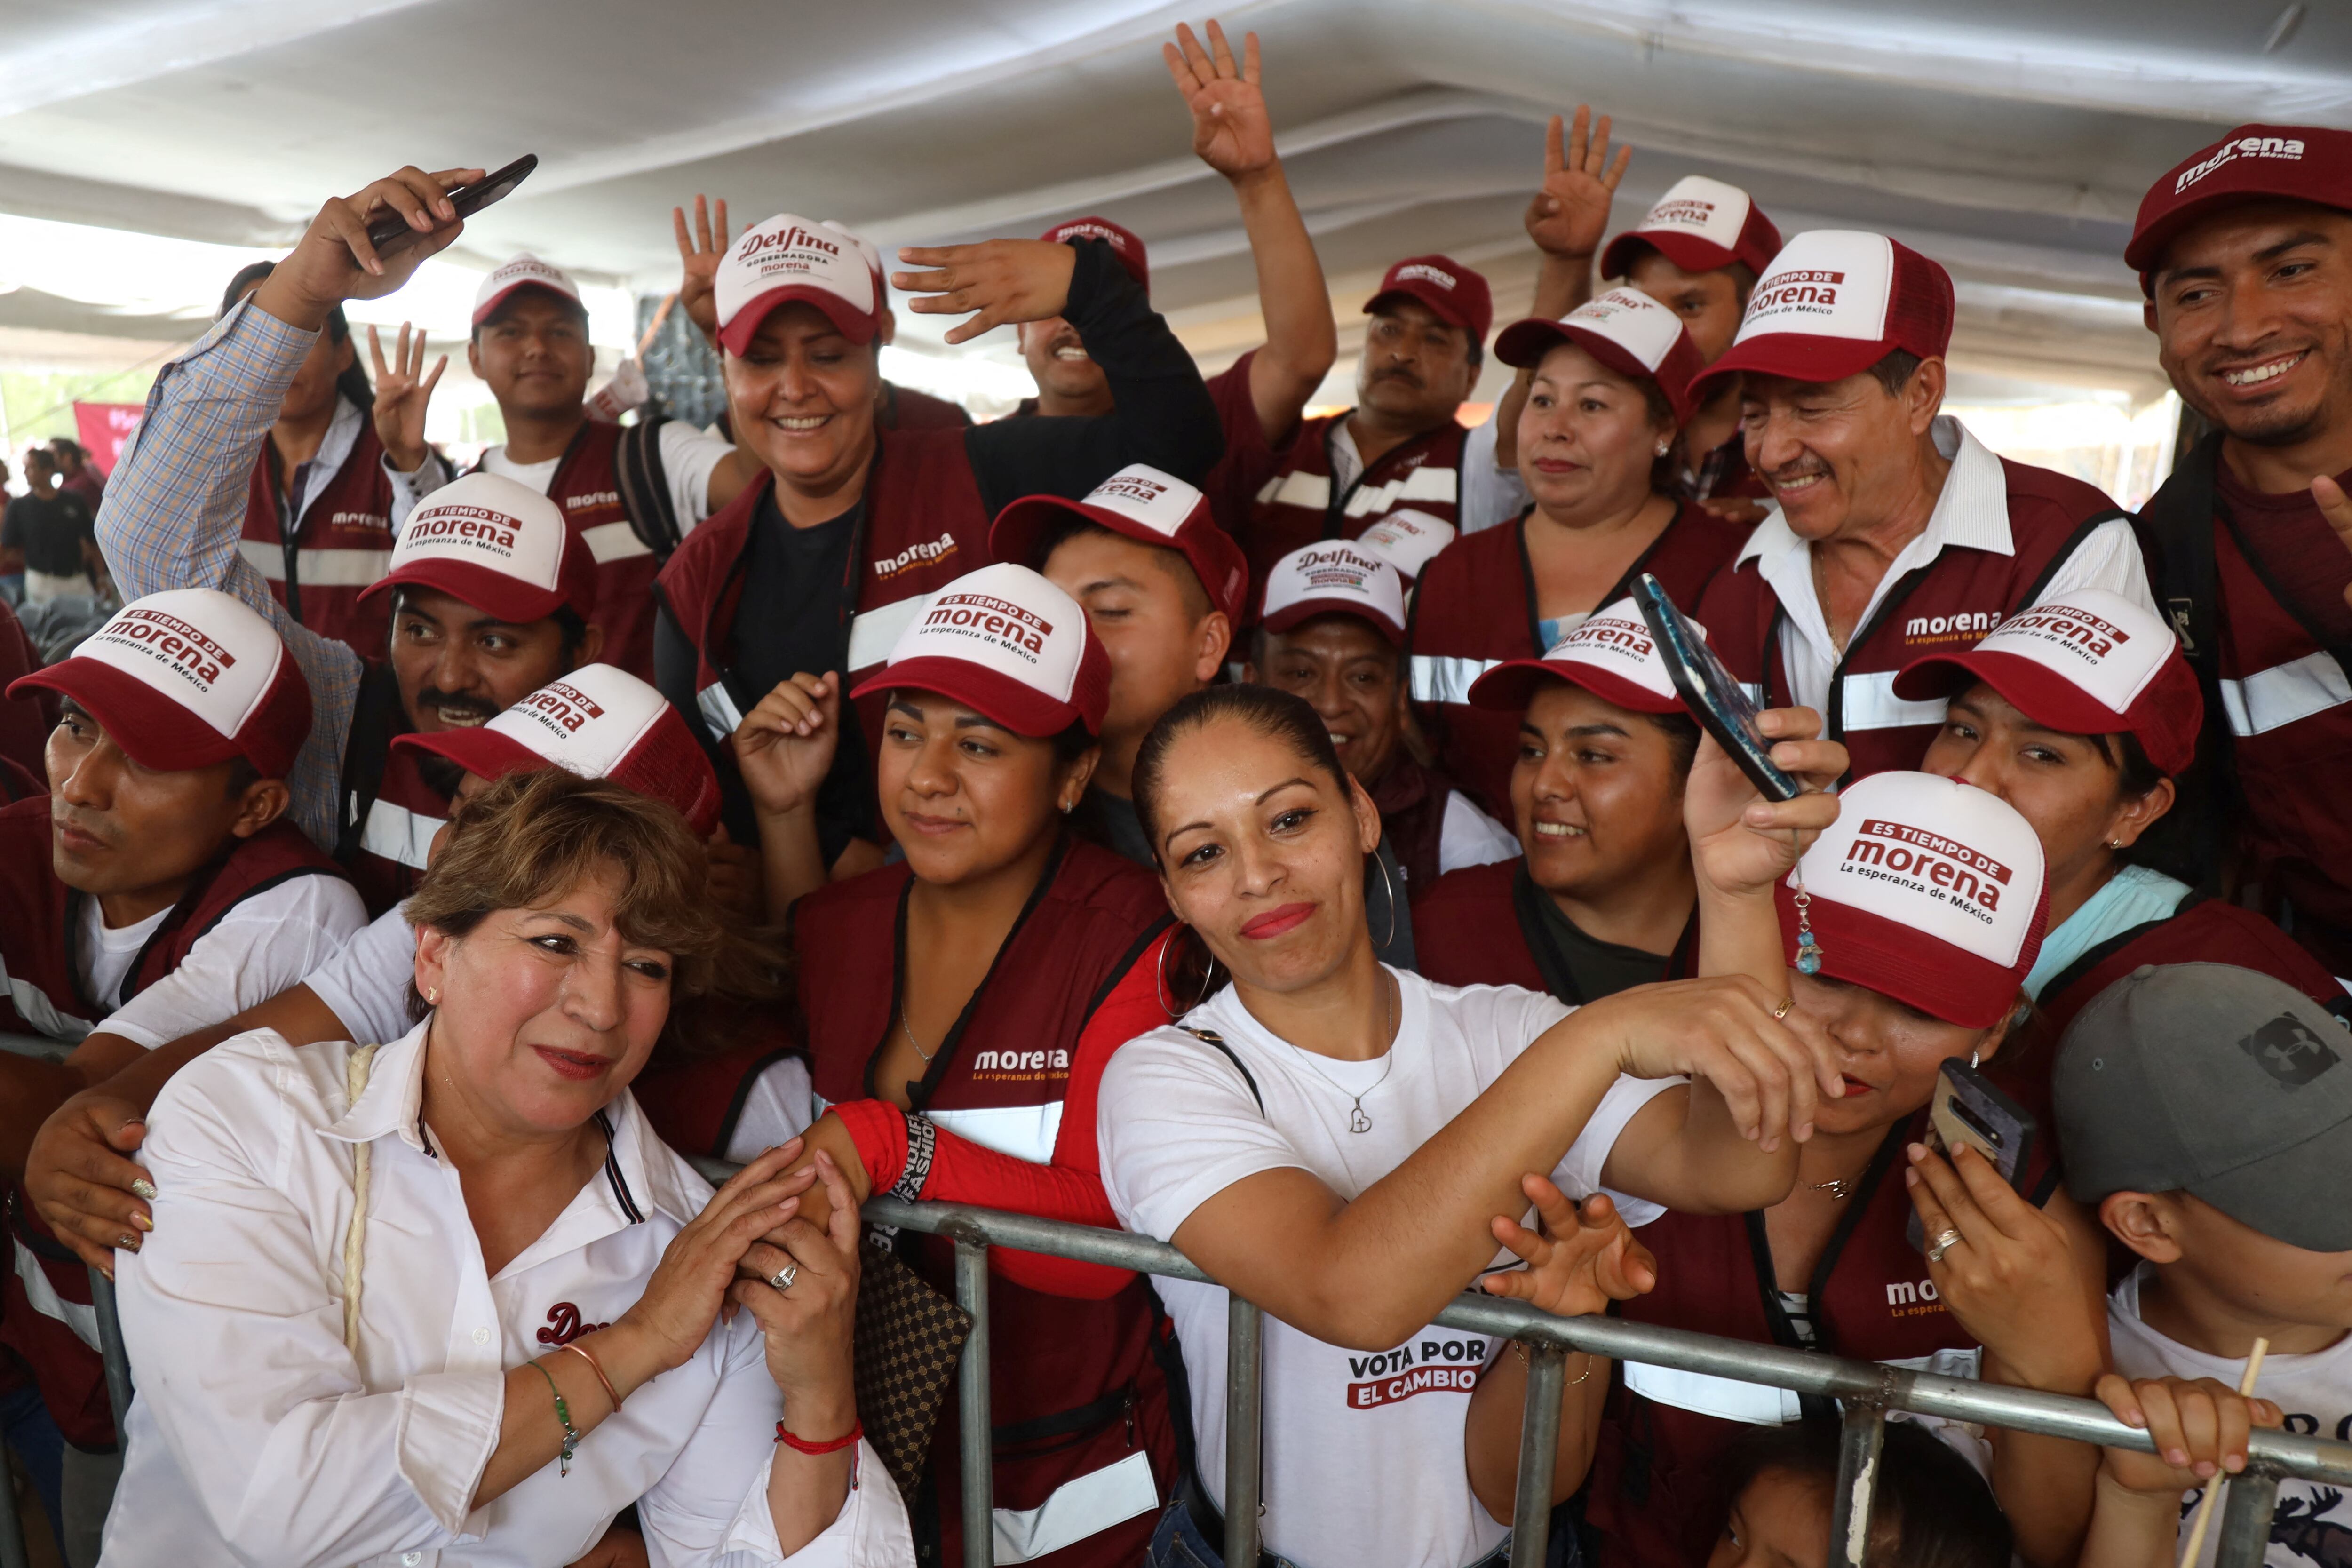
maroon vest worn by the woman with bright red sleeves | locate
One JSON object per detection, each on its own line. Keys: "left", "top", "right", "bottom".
{"left": 793, "top": 837, "right": 1176, "bottom": 1568}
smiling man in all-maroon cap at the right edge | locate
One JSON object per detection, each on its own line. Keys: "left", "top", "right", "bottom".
{"left": 2124, "top": 125, "right": 2352, "bottom": 976}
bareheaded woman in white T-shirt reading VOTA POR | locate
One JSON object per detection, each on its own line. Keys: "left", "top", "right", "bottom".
{"left": 1098, "top": 686, "right": 1844, "bottom": 1568}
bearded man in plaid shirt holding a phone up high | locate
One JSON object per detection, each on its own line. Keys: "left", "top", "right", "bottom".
{"left": 99, "top": 169, "right": 604, "bottom": 921}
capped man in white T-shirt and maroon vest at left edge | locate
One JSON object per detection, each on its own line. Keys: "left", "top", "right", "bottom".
{"left": 0, "top": 592, "right": 362, "bottom": 1561}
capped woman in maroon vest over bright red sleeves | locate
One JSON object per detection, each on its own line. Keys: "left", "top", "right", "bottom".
{"left": 786, "top": 564, "right": 1181, "bottom": 1568}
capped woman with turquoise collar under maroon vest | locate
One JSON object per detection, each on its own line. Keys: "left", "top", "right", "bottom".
{"left": 1896, "top": 588, "right": 2352, "bottom": 1043}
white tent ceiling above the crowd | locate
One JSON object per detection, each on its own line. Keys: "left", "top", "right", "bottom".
{"left": 0, "top": 0, "right": 2352, "bottom": 395}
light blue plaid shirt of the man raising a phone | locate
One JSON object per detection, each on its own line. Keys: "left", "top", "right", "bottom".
{"left": 99, "top": 301, "right": 360, "bottom": 849}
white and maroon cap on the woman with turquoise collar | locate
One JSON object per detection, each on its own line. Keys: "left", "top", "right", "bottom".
{"left": 1896, "top": 588, "right": 2204, "bottom": 773}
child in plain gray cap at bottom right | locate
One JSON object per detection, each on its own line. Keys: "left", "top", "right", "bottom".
{"left": 2053, "top": 964, "right": 2352, "bottom": 1568}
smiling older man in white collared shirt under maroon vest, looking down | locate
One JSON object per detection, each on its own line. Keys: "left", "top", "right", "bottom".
{"left": 1693, "top": 231, "right": 2154, "bottom": 778}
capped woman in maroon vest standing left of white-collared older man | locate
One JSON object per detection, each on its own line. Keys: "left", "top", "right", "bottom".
{"left": 1411, "top": 289, "right": 1740, "bottom": 816}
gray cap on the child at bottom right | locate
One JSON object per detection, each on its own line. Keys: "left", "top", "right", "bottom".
{"left": 2051, "top": 964, "right": 2352, "bottom": 1253}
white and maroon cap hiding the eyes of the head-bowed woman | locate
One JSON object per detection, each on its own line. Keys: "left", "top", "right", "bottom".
{"left": 1773, "top": 773, "right": 2049, "bottom": 1030}
